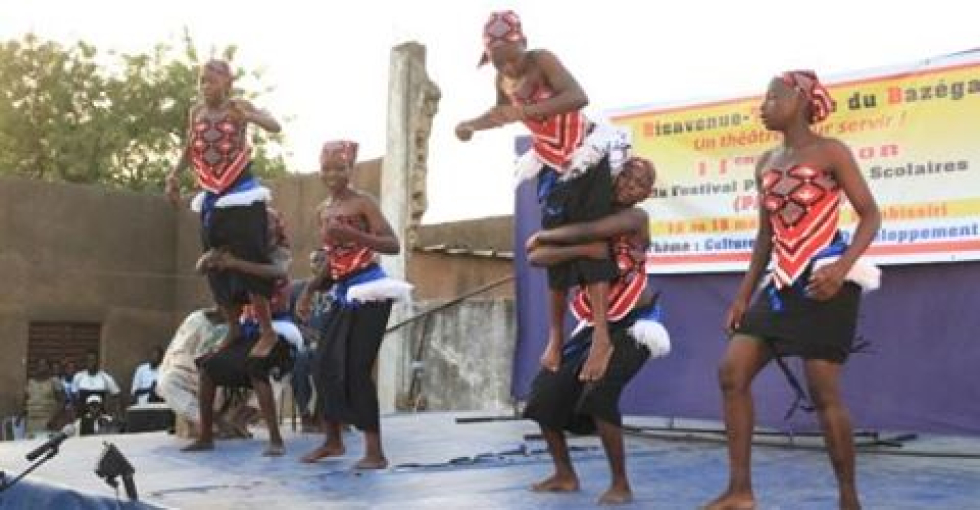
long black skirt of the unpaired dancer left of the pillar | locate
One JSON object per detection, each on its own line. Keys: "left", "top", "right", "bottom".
{"left": 313, "top": 300, "right": 392, "bottom": 432}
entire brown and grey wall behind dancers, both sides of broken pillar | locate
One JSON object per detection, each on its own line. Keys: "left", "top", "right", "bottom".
{"left": 0, "top": 159, "right": 515, "bottom": 416}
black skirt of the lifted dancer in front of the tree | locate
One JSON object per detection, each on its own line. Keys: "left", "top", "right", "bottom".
{"left": 201, "top": 198, "right": 275, "bottom": 306}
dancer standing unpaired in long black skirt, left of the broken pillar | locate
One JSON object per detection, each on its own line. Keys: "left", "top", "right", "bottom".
{"left": 296, "top": 141, "right": 411, "bottom": 469}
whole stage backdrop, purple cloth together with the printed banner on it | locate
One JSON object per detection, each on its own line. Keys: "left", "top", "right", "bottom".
{"left": 513, "top": 52, "right": 980, "bottom": 434}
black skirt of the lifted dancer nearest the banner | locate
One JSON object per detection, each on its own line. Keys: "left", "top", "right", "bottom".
{"left": 538, "top": 156, "right": 618, "bottom": 289}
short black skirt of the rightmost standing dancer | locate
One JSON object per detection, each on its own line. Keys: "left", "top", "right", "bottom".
{"left": 735, "top": 274, "right": 861, "bottom": 363}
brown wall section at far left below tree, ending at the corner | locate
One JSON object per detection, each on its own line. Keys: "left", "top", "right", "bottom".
{"left": 0, "top": 177, "right": 175, "bottom": 415}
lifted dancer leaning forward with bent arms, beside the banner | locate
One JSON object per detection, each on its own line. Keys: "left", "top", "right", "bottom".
{"left": 456, "top": 11, "right": 617, "bottom": 398}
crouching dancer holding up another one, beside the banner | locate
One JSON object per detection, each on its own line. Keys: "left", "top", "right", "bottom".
{"left": 524, "top": 158, "right": 670, "bottom": 504}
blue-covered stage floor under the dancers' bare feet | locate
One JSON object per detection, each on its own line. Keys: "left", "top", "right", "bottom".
{"left": 0, "top": 413, "right": 980, "bottom": 510}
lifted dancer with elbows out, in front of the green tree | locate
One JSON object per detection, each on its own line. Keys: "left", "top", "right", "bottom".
{"left": 167, "top": 60, "right": 281, "bottom": 359}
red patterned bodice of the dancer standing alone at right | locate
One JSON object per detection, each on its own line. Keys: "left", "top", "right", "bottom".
{"left": 762, "top": 165, "right": 840, "bottom": 288}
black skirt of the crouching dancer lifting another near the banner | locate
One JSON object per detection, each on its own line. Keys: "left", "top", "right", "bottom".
{"left": 524, "top": 314, "right": 650, "bottom": 434}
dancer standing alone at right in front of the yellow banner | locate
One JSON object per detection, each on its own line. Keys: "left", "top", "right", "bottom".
{"left": 706, "top": 71, "right": 881, "bottom": 510}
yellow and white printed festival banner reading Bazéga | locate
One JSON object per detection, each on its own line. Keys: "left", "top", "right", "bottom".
{"left": 612, "top": 52, "right": 980, "bottom": 273}
